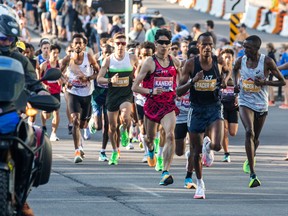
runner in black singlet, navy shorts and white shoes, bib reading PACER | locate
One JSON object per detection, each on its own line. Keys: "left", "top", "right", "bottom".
{"left": 177, "top": 33, "right": 227, "bottom": 199}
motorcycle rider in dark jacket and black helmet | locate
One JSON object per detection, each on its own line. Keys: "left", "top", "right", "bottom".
{"left": 0, "top": 14, "right": 49, "bottom": 216}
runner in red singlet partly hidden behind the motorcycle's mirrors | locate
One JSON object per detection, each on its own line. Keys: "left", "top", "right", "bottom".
{"left": 40, "top": 44, "right": 61, "bottom": 141}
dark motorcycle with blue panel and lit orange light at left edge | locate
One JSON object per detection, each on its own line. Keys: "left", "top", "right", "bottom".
{"left": 0, "top": 56, "right": 61, "bottom": 216}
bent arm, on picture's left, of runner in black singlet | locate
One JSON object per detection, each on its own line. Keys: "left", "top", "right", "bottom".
{"left": 176, "top": 58, "right": 195, "bottom": 97}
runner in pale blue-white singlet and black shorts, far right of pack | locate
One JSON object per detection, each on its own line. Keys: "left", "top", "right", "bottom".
{"left": 233, "top": 35, "right": 285, "bottom": 188}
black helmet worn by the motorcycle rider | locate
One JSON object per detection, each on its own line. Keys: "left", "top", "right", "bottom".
{"left": 0, "top": 14, "right": 20, "bottom": 38}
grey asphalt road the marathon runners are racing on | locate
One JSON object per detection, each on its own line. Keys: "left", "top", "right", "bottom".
{"left": 28, "top": 0, "right": 288, "bottom": 216}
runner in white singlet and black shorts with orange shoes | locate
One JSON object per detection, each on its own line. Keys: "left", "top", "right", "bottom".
{"left": 61, "top": 33, "right": 99, "bottom": 163}
